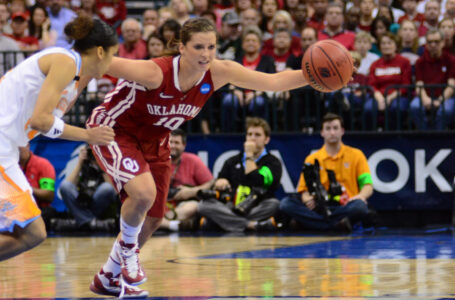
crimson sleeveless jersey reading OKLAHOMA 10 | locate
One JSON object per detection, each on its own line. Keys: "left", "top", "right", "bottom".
{"left": 87, "top": 56, "right": 217, "bottom": 143}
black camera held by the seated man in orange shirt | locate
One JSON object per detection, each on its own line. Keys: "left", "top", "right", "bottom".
{"left": 302, "top": 159, "right": 332, "bottom": 218}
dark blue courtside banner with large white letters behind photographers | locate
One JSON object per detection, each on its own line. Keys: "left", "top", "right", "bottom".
{"left": 32, "top": 132, "right": 455, "bottom": 210}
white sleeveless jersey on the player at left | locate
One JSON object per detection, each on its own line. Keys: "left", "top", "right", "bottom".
{"left": 0, "top": 47, "right": 81, "bottom": 148}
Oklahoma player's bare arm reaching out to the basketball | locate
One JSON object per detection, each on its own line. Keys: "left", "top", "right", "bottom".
{"left": 211, "top": 60, "right": 308, "bottom": 92}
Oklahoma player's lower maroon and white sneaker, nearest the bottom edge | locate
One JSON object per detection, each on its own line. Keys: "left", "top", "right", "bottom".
{"left": 90, "top": 269, "right": 149, "bottom": 298}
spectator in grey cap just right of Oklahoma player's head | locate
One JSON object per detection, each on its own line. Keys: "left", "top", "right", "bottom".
{"left": 217, "top": 11, "right": 242, "bottom": 60}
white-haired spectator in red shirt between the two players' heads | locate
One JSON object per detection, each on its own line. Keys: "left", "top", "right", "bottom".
{"left": 118, "top": 18, "right": 147, "bottom": 59}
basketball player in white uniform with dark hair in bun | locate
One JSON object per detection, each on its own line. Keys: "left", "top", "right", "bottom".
{"left": 0, "top": 17, "right": 118, "bottom": 261}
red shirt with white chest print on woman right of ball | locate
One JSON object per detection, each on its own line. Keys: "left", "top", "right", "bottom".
{"left": 368, "top": 54, "right": 412, "bottom": 95}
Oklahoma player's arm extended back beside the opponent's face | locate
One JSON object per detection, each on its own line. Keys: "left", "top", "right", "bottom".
{"left": 107, "top": 57, "right": 163, "bottom": 89}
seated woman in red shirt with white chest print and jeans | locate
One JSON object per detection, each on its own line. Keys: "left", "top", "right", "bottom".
{"left": 364, "top": 32, "right": 412, "bottom": 127}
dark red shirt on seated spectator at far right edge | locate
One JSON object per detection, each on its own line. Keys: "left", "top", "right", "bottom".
{"left": 415, "top": 49, "right": 455, "bottom": 97}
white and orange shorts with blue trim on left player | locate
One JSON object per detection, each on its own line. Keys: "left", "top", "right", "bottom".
{"left": 0, "top": 160, "right": 41, "bottom": 232}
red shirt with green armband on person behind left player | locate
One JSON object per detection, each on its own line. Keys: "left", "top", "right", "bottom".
{"left": 22, "top": 152, "right": 55, "bottom": 208}
